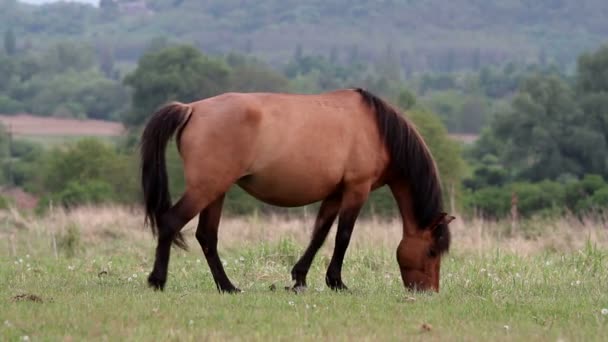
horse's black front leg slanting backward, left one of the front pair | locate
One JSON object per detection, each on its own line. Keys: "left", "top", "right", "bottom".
{"left": 291, "top": 196, "right": 341, "bottom": 291}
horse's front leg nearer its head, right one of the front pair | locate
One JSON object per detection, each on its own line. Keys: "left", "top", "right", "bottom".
{"left": 325, "top": 186, "right": 370, "bottom": 290}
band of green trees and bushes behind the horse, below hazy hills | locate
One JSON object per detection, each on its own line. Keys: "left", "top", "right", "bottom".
{"left": 0, "top": 36, "right": 608, "bottom": 218}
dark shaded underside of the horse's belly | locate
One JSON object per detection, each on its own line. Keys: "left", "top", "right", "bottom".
{"left": 237, "top": 173, "right": 339, "bottom": 207}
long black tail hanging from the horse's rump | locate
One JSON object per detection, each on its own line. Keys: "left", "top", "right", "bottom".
{"left": 141, "top": 102, "right": 192, "bottom": 249}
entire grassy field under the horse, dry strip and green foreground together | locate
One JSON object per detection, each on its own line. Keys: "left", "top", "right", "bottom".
{"left": 0, "top": 208, "right": 608, "bottom": 341}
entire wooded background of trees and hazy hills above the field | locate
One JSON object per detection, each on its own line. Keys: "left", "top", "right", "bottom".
{"left": 0, "top": 0, "right": 608, "bottom": 218}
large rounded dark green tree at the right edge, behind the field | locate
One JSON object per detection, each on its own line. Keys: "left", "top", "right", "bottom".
{"left": 480, "top": 74, "right": 607, "bottom": 181}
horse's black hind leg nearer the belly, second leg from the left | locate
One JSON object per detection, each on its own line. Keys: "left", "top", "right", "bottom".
{"left": 196, "top": 194, "right": 240, "bottom": 293}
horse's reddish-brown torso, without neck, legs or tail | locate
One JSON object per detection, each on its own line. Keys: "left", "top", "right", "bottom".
{"left": 182, "top": 90, "right": 388, "bottom": 206}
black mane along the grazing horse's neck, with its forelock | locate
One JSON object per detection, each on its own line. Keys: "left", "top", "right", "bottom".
{"left": 355, "top": 88, "right": 449, "bottom": 251}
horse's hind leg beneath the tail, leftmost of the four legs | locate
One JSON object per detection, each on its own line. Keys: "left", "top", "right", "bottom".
{"left": 148, "top": 191, "right": 218, "bottom": 290}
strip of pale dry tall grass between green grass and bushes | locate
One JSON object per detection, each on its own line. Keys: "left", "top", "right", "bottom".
{"left": 0, "top": 206, "right": 608, "bottom": 256}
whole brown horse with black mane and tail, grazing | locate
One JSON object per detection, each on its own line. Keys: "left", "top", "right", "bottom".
{"left": 141, "top": 89, "right": 453, "bottom": 292}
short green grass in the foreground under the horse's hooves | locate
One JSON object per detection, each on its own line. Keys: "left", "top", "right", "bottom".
{"left": 0, "top": 228, "right": 608, "bottom": 341}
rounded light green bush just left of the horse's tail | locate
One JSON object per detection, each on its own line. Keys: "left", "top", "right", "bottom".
{"left": 16, "top": 139, "right": 139, "bottom": 210}
